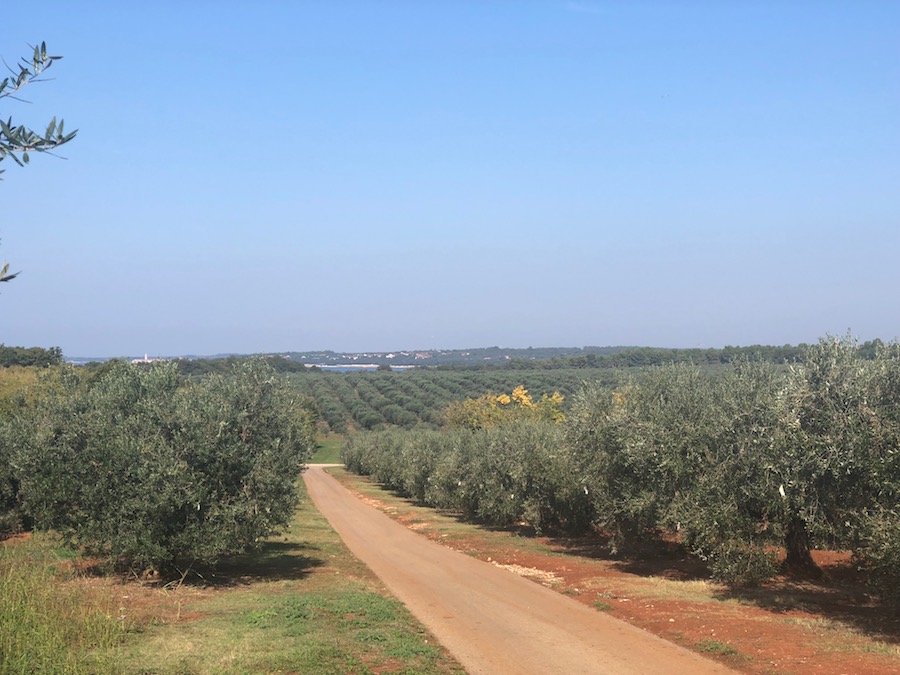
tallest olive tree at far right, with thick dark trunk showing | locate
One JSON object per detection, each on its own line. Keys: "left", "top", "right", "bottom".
{"left": 769, "top": 336, "right": 898, "bottom": 576}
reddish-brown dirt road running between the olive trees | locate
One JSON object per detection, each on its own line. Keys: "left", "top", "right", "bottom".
{"left": 304, "top": 465, "right": 731, "bottom": 675}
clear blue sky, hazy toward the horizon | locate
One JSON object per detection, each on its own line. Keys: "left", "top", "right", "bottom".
{"left": 0, "top": 0, "right": 900, "bottom": 356}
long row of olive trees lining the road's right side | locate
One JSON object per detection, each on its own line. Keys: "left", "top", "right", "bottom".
{"left": 344, "top": 338, "right": 900, "bottom": 602}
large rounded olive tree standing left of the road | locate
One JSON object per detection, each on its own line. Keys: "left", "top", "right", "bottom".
{"left": 17, "top": 361, "right": 314, "bottom": 571}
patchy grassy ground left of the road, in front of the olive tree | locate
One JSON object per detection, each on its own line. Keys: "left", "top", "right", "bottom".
{"left": 0, "top": 483, "right": 462, "bottom": 675}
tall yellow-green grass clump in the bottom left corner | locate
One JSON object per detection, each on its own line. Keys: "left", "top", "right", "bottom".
{"left": 0, "top": 536, "right": 124, "bottom": 674}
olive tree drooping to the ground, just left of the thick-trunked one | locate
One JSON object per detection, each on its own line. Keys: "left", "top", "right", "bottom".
{"left": 661, "top": 361, "right": 784, "bottom": 584}
